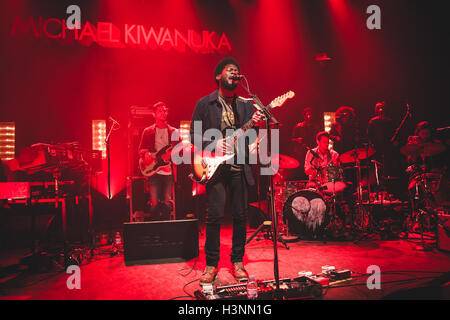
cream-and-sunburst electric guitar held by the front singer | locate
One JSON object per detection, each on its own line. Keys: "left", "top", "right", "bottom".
{"left": 192, "top": 91, "right": 295, "bottom": 184}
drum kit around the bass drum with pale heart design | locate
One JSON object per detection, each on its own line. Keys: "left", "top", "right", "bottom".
{"left": 268, "top": 146, "right": 410, "bottom": 240}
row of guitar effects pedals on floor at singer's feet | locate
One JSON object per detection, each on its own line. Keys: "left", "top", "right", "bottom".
{"left": 194, "top": 276, "right": 322, "bottom": 300}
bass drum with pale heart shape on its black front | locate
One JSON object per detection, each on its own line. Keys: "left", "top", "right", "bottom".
{"left": 283, "top": 189, "right": 330, "bottom": 240}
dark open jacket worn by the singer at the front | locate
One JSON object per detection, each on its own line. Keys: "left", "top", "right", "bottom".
{"left": 190, "top": 90, "right": 255, "bottom": 185}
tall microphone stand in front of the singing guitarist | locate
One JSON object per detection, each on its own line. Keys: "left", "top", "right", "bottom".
{"left": 239, "top": 76, "right": 282, "bottom": 300}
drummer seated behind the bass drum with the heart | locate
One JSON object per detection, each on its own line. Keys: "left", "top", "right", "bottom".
{"left": 305, "top": 131, "right": 339, "bottom": 189}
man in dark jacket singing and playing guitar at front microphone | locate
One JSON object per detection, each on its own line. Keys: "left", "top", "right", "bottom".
{"left": 190, "top": 58, "right": 262, "bottom": 285}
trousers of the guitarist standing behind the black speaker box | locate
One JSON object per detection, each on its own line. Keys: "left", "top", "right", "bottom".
{"left": 148, "top": 174, "right": 173, "bottom": 220}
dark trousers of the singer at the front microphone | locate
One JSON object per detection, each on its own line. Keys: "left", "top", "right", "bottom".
{"left": 205, "top": 168, "right": 248, "bottom": 267}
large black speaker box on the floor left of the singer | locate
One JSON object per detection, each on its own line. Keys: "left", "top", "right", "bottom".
{"left": 123, "top": 219, "right": 199, "bottom": 266}
